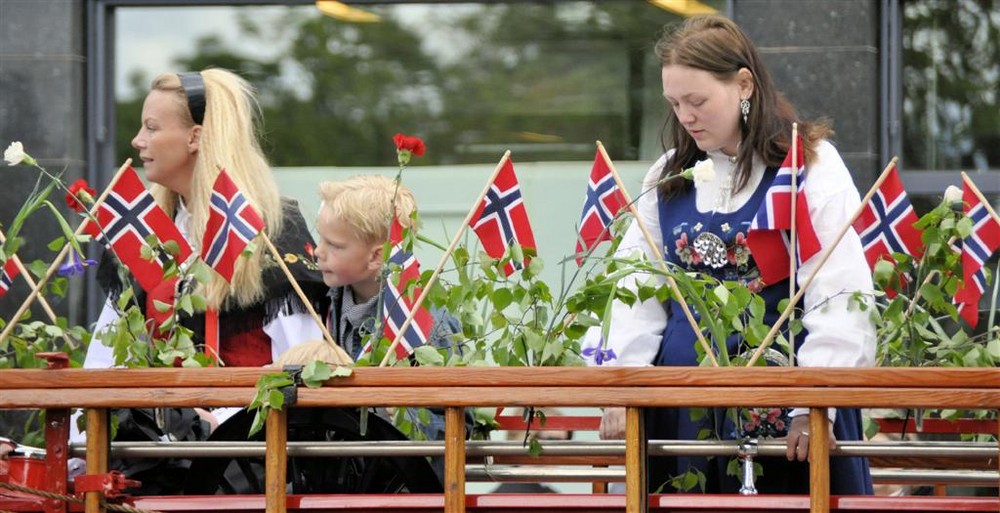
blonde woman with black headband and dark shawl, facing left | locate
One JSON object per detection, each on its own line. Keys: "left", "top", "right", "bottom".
{"left": 85, "top": 69, "right": 326, "bottom": 367}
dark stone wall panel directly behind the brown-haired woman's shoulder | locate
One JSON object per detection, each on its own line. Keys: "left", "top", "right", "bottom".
{"left": 733, "top": 0, "right": 885, "bottom": 188}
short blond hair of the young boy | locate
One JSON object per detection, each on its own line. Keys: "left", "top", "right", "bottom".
{"left": 319, "top": 175, "right": 417, "bottom": 245}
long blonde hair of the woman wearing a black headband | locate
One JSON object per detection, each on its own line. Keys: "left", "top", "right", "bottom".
{"left": 151, "top": 69, "right": 284, "bottom": 309}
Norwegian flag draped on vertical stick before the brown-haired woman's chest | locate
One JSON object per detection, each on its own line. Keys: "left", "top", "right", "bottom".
{"left": 747, "top": 138, "right": 821, "bottom": 285}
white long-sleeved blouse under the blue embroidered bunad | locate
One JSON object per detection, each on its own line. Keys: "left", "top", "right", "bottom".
{"left": 583, "top": 141, "right": 875, "bottom": 382}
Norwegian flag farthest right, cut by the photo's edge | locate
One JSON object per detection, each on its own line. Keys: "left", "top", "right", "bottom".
{"left": 955, "top": 182, "right": 1000, "bottom": 328}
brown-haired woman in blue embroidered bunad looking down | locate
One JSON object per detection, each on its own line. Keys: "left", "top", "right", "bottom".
{"left": 586, "top": 16, "right": 875, "bottom": 494}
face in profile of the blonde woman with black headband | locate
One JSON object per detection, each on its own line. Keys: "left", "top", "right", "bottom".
{"left": 132, "top": 90, "right": 201, "bottom": 198}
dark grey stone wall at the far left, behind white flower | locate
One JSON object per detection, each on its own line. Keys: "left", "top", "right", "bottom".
{"left": 0, "top": 0, "right": 87, "bottom": 321}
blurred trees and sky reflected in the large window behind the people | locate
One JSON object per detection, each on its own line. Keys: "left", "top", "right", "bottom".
{"left": 116, "top": 0, "right": 723, "bottom": 166}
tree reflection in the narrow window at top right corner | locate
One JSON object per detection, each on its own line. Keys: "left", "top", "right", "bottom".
{"left": 902, "top": 0, "right": 1000, "bottom": 170}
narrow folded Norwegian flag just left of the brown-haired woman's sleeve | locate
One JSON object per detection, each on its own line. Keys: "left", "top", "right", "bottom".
{"left": 576, "top": 150, "right": 626, "bottom": 265}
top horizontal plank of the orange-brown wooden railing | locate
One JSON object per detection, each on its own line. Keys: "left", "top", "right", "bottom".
{"left": 0, "top": 367, "right": 1000, "bottom": 390}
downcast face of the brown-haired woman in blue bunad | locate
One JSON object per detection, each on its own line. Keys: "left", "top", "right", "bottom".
{"left": 663, "top": 64, "right": 752, "bottom": 155}
